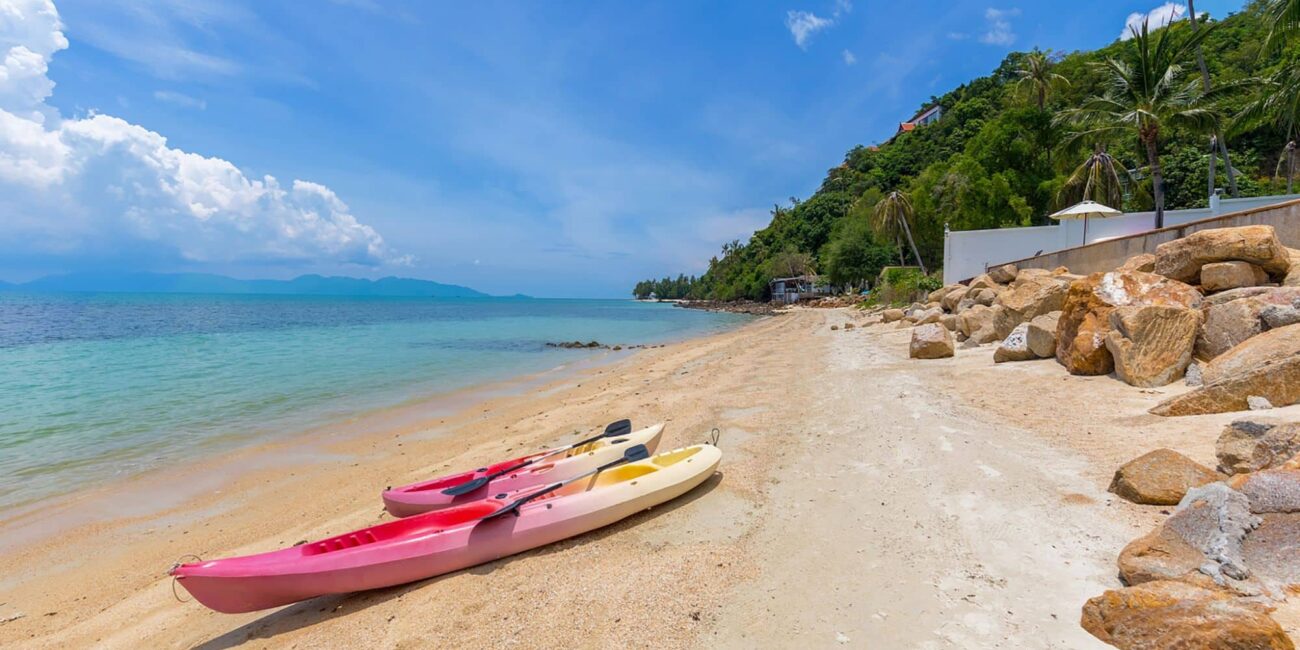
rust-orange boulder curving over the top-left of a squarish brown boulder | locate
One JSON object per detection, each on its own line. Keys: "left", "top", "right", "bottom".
{"left": 1049, "top": 270, "right": 1201, "bottom": 374}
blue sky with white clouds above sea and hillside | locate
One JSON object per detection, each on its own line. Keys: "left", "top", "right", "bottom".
{"left": 0, "top": 0, "right": 1242, "bottom": 298}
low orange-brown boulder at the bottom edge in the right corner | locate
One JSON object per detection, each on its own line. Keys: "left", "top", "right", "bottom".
{"left": 1079, "top": 580, "right": 1295, "bottom": 650}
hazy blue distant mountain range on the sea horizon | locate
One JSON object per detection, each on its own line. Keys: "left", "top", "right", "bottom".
{"left": 0, "top": 273, "right": 491, "bottom": 298}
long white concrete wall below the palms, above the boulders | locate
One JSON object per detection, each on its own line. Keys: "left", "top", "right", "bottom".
{"left": 944, "top": 194, "right": 1300, "bottom": 283}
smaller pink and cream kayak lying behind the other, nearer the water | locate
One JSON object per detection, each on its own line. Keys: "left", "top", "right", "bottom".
{"left": 384, "top": 423, "right": 663, "bottom": 517}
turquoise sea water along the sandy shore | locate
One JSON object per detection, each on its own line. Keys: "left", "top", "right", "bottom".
{"left": 0, "top": 294, "right": 748, "bottom": 507}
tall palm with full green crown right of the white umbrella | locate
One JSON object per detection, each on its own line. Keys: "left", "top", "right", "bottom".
{"left": 1060, "top": 21, "right": 1227, "bottom": 228}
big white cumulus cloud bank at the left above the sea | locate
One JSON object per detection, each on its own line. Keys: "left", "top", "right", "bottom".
{"left": 0, "top": 0, "right": 395, "bottom": 267}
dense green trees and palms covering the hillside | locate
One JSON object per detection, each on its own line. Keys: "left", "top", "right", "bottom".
{"left": 634, "top": 0, "right": 1300, "bottom": 300}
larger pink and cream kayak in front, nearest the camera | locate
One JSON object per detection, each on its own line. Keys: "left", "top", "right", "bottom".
{"left": 170, "top": 445, "right": 722, "bottom": 614}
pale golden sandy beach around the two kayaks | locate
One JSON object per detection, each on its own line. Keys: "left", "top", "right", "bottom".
{"left": 0, "top": 309, "right": 1300, "bottom": 649}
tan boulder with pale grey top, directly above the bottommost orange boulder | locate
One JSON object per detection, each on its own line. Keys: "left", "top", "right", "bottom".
{"left": 1119, "top": 482, "right": 1261, "bottom": 585}
